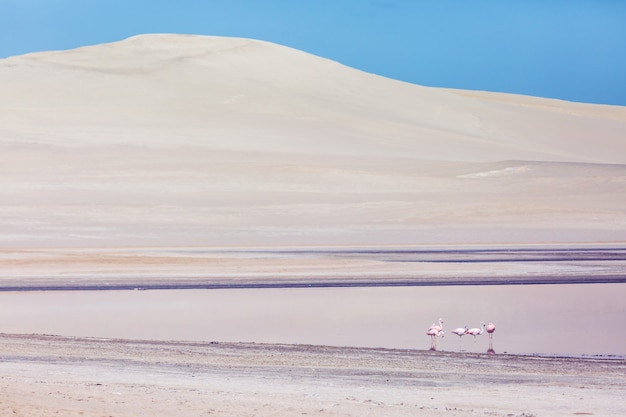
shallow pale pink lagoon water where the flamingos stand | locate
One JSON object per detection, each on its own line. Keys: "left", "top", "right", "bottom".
{"left": 0, "top": 284, "right": 626, "bottom": 355}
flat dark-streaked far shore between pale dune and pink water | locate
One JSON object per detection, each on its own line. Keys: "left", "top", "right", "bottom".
{"left": 0, "top": 244, "right": 626, "bottom": 291}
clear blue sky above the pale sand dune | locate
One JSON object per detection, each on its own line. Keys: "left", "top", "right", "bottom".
{"left": 0, "top": 0, "right": 626, "bottom": 105}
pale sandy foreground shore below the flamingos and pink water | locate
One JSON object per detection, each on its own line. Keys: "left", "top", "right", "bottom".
{"left": 0, "top": 334, "right": 626, "bottom": 417}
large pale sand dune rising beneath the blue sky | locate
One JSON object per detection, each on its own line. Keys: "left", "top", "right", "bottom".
{"left": 0, "top": 35, "right": 626, "bottom": 247}
